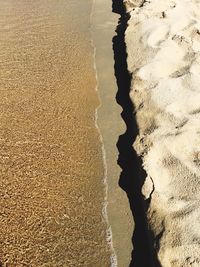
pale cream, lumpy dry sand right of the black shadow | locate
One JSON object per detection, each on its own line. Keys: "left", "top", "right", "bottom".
{"left": 126, "top": 0, "right": 200, "bottom": 267}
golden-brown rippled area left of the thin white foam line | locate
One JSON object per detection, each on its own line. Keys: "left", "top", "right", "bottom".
{"left": 0, "top": 0, "right": 109, "bottom": 267}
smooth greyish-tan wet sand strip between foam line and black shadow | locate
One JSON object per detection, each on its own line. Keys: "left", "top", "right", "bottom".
{"left": 92, "top": 0, "right": 134, "bottom": 267}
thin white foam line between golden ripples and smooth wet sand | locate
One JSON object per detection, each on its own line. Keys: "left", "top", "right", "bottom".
{"left": 90, "top": 0, "right": 118, "bottom": 267}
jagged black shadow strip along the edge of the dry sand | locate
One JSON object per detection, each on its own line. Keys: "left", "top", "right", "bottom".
{"left": 112, "top": 0, "right": 160, "bottom": 267}
